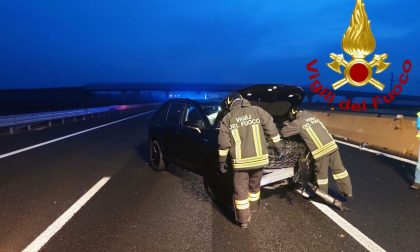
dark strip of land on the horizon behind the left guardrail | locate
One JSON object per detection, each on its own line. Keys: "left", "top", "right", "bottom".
{"left": 0, "top": 87, "right": 162, "bottom": 115}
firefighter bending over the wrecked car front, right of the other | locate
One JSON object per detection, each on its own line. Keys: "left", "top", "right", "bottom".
{"left": 280, "top": 107, "right": 352, "bottom": 198}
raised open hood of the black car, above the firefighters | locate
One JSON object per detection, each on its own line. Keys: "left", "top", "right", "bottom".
{"left": 237, "top": 84, "right": 305, "bottom": 119}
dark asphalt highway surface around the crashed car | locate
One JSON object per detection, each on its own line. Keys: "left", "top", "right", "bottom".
{"left": 0, "top": 109, "right": 420, "bottom": 251}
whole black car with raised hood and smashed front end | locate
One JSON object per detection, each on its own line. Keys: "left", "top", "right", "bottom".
{"left": 149, "top": 84, "right": 308, "bottom": 194}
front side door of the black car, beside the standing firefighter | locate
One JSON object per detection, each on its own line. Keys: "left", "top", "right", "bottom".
{"left": 179, "top": 104, "right": 209, "bottom": 171}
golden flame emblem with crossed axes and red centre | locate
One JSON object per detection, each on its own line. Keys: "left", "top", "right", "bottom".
{"left": 327, "top": 0, "right": 391, "bottom": 91}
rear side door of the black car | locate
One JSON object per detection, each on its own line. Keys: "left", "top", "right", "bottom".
{"left": 163, "top": 102, "right": 185, "bottom": 164}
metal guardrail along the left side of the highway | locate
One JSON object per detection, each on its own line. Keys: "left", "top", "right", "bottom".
{"left": 0, "top": 103, "right": 156, "bottom": 134}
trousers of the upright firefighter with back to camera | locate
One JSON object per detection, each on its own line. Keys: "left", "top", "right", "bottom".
{"left": 233, "top": 169, "right": 263, "bottom": 223}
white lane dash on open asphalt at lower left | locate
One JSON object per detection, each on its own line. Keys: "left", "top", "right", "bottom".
{"left": 23, "top": 177, "right": 110, "bottom": 252}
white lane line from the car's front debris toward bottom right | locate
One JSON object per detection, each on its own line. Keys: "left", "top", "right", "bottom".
{"left": 310, "top": 200, "right": 386, "bottom": 252}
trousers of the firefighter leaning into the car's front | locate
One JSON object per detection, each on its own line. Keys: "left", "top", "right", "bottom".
{"left": 315, "top": 150, "right": 352, "bottom": 196}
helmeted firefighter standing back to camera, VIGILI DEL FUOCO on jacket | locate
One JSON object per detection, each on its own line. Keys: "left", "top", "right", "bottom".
{"left": 218, "top": 93, "right": 280, "bottom": 228}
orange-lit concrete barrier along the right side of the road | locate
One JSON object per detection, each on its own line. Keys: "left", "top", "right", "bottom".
{"left": 314, "top": 111, "right": 419, "bottom": 161}
